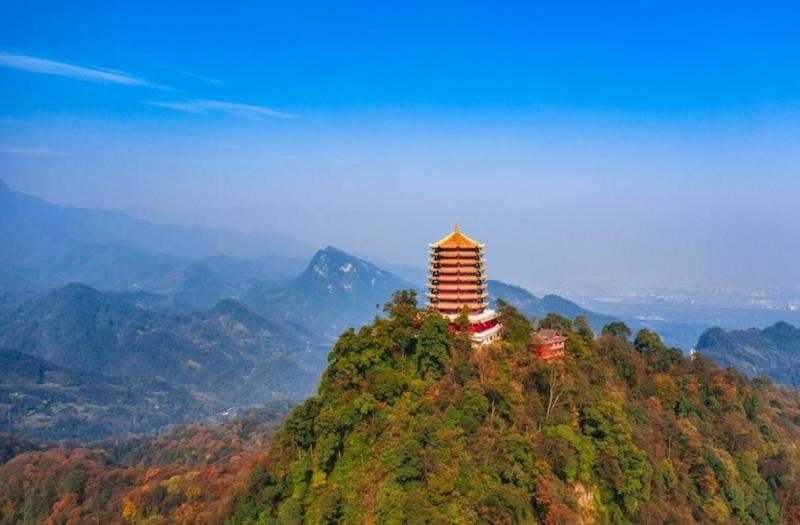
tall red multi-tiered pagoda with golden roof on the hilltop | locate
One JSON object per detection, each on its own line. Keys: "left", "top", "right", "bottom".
{"left": 427, "top": 224, "right": 500, "bottom": 345}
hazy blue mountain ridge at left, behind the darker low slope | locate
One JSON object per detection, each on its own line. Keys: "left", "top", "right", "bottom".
{"left": 0, "top": 284, "right": 320, "bottom": 410}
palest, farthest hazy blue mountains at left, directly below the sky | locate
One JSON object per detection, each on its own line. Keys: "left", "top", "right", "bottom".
{"left": 0, "top": 181, "right": 313, "bottom": 294}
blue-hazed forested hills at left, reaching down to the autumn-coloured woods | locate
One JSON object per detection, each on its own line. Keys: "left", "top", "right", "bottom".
{"left": 0, "top": 284, "right": 327, "bottom": 441}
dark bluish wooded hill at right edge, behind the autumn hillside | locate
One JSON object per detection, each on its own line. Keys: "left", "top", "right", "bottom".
{"left": 697, "top": 322, "right": 800, "bottom": 387}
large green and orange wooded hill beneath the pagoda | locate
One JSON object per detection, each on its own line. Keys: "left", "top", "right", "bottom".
{"left": 227, "top": 293, "right": 800, "bottom": 524}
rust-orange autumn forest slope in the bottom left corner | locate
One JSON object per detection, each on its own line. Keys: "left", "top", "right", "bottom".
{"left": 0, "top": 402, "right": 289, "bottom": 525}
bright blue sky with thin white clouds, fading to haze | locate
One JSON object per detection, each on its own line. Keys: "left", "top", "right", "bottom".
{"left": 0, "top": 2, "right": 800, "bottom": 290}
